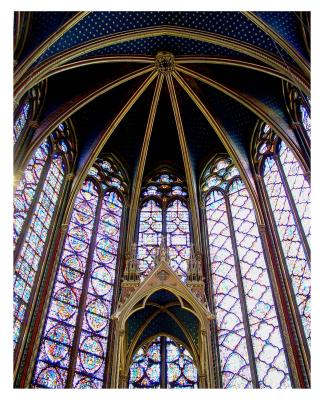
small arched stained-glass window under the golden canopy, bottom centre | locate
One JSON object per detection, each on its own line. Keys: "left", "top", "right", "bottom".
{"left": 129, "top": 336, "right": 198, "bottom": 389}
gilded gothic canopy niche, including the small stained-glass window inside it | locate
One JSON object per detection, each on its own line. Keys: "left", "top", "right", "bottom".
{"left": 111, "top": 241, "right": 215, "bottom": 388}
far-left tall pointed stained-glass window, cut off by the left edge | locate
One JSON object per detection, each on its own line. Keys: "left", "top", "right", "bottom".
{"left": 13, "top": 124, "right": 73, "bottom": 347}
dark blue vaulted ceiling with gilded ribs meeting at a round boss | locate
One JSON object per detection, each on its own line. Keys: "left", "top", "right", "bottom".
{"left": 14, "top": 11, "right": 310, "bottom": 192}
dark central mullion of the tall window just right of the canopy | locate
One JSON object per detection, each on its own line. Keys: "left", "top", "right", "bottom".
{"left": 224, "top": 195, "right": 260, "bottom": 388}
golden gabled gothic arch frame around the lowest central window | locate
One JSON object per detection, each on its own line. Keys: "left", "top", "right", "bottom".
{"left": 111, "top": 244, "right": 214, "bottom": 388}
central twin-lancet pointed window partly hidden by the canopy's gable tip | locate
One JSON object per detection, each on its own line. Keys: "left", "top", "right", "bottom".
{"left": 137, "top": 171, "right": 191, "bottom": 280}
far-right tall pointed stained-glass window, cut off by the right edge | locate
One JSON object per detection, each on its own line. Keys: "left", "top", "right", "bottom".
{"left": 255, "top": 124, "right": 311, "bottom": 346}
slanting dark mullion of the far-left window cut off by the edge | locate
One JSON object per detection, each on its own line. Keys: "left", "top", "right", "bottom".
{"left": 14, "top": 155, "right": 53, "bottom": 265}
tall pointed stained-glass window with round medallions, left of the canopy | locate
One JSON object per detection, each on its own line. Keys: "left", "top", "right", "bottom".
{"left": 32, "top": 155, "right": 126, "bottom": 388}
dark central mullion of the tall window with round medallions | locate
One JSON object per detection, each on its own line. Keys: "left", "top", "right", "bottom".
{"left": 66, "top": 193, "right": 104, "bottom": 388}
